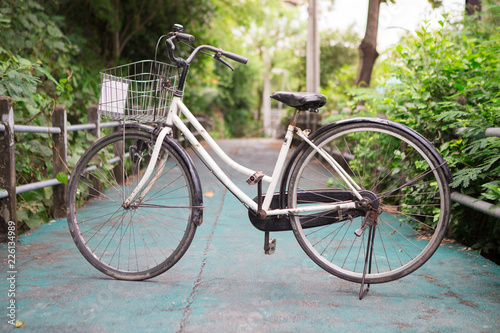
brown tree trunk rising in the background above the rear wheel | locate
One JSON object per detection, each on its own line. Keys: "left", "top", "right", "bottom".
{"left": 355, "top": 0, "right": 380, "bottom": 87}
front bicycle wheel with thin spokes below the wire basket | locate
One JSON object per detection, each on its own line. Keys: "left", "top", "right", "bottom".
{"left": 68, "top": 130, "right": 201, "bottom": 280}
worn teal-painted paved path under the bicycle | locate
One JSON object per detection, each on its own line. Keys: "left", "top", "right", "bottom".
{"left": 0, "top": 139, "right": 500, "bottom": 332}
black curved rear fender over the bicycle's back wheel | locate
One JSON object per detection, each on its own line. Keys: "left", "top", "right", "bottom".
{"left": 280, "top": 117, "right": 453, "bottom": 207}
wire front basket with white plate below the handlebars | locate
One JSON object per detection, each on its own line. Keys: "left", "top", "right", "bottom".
{"left": 98, "top": 60, "right": 179, "bottom": 122}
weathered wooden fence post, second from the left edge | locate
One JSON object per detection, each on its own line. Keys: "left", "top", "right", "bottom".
{"left": 52, "top": 105, "right": 68, "bottom": 219}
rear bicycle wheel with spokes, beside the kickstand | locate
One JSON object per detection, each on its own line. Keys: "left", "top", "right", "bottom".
{"left": 288, "top": 122, "right": 450, "bottom": 283}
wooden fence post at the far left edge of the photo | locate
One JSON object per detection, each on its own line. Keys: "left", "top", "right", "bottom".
{"left": 0, "top": 96, "right": 18, "bottom": 242}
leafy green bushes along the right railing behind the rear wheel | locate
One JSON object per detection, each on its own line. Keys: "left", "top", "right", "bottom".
{"left": 358, "top": 6, "right": 500, "bottom": 260}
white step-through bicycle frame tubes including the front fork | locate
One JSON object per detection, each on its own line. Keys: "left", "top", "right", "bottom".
{"left": 125, "top": 96, "right": 362, "bottom": 216}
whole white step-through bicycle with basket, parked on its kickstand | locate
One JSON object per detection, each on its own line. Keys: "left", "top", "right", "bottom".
{"left": 67, "top": 25, "right": 451, "bottom": 296}
